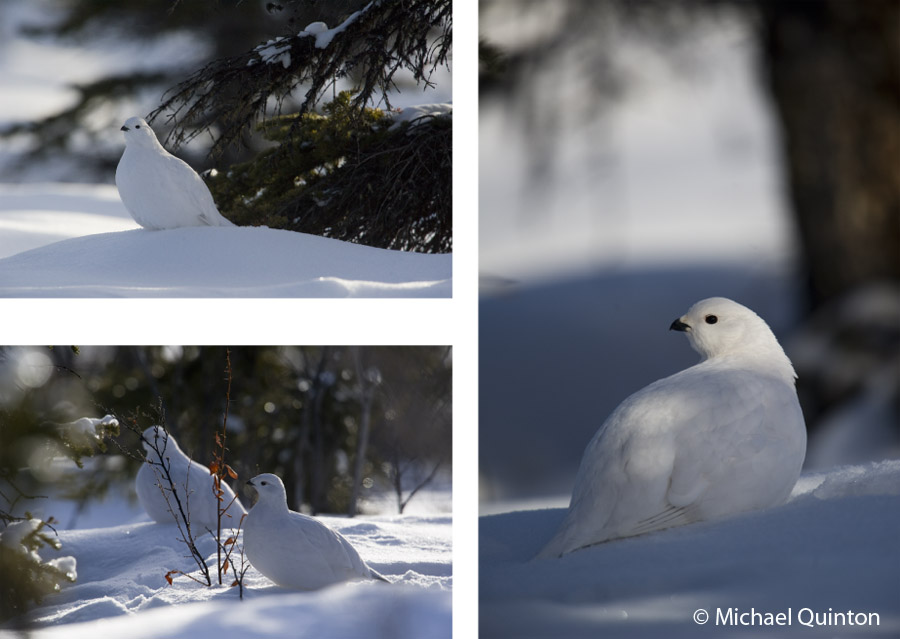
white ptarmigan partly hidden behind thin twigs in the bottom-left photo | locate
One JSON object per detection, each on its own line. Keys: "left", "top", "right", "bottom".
{"left": 134, "top": 426, "right": 247, "bottom": 537}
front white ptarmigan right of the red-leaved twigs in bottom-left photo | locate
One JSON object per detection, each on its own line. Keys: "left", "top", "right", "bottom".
{"left": 244, "top": 473, "right": 387, "bottom": 590}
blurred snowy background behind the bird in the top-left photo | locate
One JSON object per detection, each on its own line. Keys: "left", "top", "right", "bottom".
{"left": 0, "top": 0, "right": 452, "bottom": 184}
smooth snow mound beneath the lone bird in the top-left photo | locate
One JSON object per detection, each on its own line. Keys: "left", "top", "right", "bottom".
{"left": 0, "top": 227, "right": 452, "bottom": 297}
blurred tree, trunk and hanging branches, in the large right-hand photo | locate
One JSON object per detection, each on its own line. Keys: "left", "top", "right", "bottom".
{"left": 480, "top": 0, "right": 900, "bottom": 309}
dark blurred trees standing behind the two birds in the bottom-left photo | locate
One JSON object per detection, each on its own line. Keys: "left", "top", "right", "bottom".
{"left": 82, "top": 346, "right": 451, "bottom": 513}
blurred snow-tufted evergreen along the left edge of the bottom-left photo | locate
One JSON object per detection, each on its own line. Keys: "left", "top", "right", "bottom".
{"left": 0, "top": 347, "right": 118, "bottom": 627}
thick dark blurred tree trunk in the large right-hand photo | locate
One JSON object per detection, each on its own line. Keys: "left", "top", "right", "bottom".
{"left": 760, "top": 0, "right": 900, "bottom": 308}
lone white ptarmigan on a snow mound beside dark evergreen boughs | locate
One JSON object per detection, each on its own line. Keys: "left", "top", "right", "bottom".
{"left": 116, "top": 117, "right": 234, "bottom": 230}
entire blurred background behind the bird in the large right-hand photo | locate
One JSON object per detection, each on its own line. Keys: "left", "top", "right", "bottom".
{"left": 479, "top": 0, "right": 900, "bottom": 513}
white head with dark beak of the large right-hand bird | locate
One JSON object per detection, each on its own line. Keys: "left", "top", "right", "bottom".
{"left": 669, "top": 297, "right": 796, "bottom": 380}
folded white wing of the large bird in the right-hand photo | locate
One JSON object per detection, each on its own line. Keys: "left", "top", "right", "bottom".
{"left": 542, "top": 367, "right": 765, "bottom": 556}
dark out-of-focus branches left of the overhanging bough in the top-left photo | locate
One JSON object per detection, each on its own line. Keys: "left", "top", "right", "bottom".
{"left": 3, "top": 0, "right": 284, "bottom": 177}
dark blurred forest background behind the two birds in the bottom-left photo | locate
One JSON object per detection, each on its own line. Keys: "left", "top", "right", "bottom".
{"left": 0, "top": 346, "right": 452, "bottom": 528}
